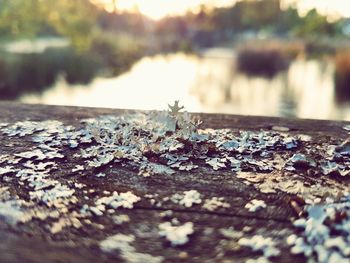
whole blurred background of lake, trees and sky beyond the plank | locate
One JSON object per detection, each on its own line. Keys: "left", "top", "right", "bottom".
{"left": 0, "top": 0, "right": 350, "bottom": 120}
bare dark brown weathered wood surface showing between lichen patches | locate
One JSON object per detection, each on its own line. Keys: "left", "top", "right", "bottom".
{"left": 0, "top": 102, "right": 349, "bottom": 262}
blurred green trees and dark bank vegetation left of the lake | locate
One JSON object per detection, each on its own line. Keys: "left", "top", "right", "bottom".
{"left": 0, "top": 0, "right": 146, "bottom": 98}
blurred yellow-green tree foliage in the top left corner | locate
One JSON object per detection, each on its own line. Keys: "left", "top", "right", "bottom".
{"left": 0, "top": 0, "right": 98, "bottom": 50}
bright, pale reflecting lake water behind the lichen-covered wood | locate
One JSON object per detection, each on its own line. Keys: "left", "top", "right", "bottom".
{"left": 19, "top": 48, "right": 350, "bottom": 120}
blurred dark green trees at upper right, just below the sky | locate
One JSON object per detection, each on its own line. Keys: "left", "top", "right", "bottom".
{"left": 180, "top": 0, "right": 342, "bottom": 43}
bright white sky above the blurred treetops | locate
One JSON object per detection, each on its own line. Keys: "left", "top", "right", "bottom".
{"left": 94, "top": 0, "right": 350, "bottom": 19}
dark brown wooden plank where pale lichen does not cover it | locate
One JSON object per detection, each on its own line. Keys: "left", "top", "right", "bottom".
{"left": 0, "top": 102, "right": 350, "bottom": 262}
